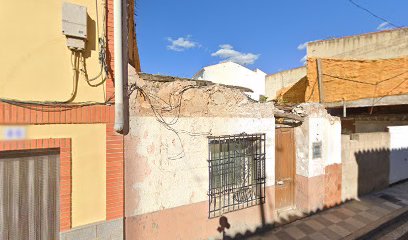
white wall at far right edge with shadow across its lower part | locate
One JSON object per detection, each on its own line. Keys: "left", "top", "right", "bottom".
{"left": 388, "top": 126, "right": 408, "bottom": 184}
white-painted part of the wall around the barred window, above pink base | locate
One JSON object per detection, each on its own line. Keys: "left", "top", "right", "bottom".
{"left": 125, "top": 116, "right": 275, "bottom": 217}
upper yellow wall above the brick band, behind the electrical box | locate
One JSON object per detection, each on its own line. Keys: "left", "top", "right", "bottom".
{"left": 0, "top": 0, "right": 105, "bottom": 101}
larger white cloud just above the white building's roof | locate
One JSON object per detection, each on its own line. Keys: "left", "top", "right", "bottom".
{"left": 211, "top": 44, "right": 259, "bottom": 65}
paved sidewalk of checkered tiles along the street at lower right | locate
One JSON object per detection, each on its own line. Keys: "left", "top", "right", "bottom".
{"left": 248, "top": 182, "right": 408, "bottom": 240}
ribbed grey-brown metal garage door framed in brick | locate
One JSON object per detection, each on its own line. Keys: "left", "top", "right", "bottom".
{"left": 0, "top": 151, "right": 59, "bottom": 240}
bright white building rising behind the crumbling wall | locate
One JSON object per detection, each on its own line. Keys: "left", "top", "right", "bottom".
{"left": 193, "top": 62, "right": 266, "bottom": 101}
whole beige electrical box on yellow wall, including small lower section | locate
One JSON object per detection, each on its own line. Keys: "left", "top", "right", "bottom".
{"left": 62, "top": 2, "right": 88, "bottom": 51}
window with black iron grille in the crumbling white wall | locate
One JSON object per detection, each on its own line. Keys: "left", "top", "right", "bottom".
{"left": 208, "top": 133, "right": 265, "bottom": 218}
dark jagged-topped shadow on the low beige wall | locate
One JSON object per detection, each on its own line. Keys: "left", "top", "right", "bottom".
{"left": 354, "top": 148, "right": 391, "bottom": 196}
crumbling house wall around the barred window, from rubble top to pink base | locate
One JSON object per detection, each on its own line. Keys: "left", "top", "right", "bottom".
{"left": 125, "top": 74, "right": 275, "bottom": 239}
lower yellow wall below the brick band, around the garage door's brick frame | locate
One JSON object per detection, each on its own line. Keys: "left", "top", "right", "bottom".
{"left": 0, "top": 124, "right": 106, "bottom": 227}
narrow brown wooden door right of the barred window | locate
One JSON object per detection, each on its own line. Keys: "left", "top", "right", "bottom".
{"left": 275, "top": 128, "right": 296, "bottom": 210}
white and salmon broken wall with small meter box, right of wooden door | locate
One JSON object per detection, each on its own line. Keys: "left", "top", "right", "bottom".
{"left": 295, "top": 104, "right": 342, "bottom": 212}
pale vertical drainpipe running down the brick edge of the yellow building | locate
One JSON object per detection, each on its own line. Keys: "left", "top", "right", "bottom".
{"left": 113, "top": 0, "right": 124, "bottom": 132}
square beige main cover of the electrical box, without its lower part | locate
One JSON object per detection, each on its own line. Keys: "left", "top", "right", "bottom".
{"left": 62, "top": 2, "right": 87, "bottom": 39}
